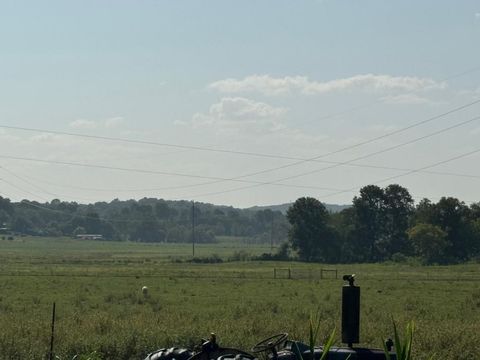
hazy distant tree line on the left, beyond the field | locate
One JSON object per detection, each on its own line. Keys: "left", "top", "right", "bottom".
{"left": 0, "top": 197, "right": 288, "bottom": 243}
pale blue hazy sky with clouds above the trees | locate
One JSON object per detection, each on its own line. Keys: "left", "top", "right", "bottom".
{"left": 0, "top": 0, "right": 480, "bottom": 207}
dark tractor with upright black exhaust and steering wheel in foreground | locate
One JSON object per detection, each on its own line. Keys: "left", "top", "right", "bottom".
{"left": 145, "top": 274, "right": 396, "bottom": 360}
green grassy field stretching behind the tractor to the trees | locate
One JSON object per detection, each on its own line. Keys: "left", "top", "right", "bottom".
{"left": 0, "top": 238, "right": 480, "bottom": 359}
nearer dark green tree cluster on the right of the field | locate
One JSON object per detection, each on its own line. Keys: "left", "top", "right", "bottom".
{"left": 287, "top": 184, "right": 480, "bottom": 264}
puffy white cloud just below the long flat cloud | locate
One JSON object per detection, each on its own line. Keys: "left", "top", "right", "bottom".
{"left": 192, "top": 97, "right": 287, "bottom": 133}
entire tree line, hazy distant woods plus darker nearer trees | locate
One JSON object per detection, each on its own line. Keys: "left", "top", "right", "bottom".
{"left": 0, "top": 184, "right": 480, "bottom": 264}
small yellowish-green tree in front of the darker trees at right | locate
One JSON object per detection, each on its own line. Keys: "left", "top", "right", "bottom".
{"left": 408, "top": 223, "right": 449, "bottom": 264}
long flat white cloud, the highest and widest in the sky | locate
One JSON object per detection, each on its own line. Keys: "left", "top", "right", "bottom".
{"left": 209, "top": 74, "right": 446, "bottom": 96}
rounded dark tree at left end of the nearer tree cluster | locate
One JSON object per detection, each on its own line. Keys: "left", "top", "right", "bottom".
{"left": 287, "top": 197, "right": 338, "bottom": 262}
